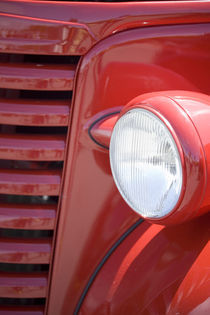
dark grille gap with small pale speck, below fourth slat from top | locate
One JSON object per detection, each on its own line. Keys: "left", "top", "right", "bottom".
{"left": 0, "top": 194, "right": 58, "bottom": 206}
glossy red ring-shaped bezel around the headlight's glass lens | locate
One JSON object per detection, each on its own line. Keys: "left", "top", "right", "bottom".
{"left": 110, "top": 92, "right": 206, "bottom": 225}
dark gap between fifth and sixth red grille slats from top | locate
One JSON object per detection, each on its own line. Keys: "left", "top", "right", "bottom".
{"left": 0, "top": 229, "right": 53, "bottom": 239}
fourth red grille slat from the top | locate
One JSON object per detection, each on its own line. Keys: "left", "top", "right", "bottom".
{"left": 0, "top": 169, "right": 61, "bottom": 196}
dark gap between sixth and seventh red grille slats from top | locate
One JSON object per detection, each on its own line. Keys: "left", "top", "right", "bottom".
{"left": 0, "top": 263, "right": 49, "bottom": 273}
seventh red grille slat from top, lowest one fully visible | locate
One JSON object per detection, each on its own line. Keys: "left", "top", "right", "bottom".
{"left": 0, "top": 272, "right": 47, "bottom": 298}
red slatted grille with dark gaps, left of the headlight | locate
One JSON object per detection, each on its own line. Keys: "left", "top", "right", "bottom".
{"left": 0, "top": 53, "right": 79, "bottom": 315}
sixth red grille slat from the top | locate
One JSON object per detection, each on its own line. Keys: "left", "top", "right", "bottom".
{"left": 0, "top": 238, "right": 51, "bottom": 264}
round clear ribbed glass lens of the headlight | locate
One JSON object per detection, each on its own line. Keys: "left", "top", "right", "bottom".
{"left": 110, "top": 108, "right": 183, "bottom": 218}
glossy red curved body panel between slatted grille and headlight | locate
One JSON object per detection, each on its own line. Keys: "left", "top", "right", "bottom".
{"left": 48, "top": 21, "right": 210, "bottom": 314}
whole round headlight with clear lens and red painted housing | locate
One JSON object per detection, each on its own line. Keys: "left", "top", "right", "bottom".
{"left": 110, "top": 91, "right": 210, "bottom": 225}
